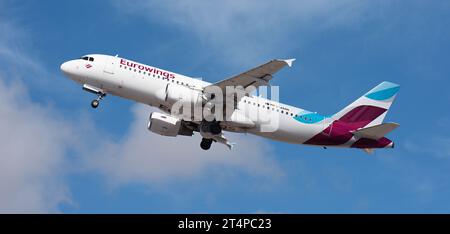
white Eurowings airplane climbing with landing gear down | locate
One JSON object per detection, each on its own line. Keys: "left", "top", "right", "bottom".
{"left": 60, "top": 54, "right": 400, "bottom": 154}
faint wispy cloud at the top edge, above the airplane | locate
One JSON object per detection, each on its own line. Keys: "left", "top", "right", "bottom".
{"left": 113, "top": 0, "right": 369, "bottom": 65}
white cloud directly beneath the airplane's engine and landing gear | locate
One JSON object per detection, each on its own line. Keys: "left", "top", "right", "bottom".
{"left": 86, "top": 105, "right": 282, "bottom": 185}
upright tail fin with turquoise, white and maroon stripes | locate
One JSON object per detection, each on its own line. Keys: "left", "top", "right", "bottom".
{"left": 333, "top": 81, "right": 400, "bottom": 130}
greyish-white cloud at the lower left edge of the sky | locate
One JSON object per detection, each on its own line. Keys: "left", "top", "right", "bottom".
{"left": 0, "top": 77, "right": 71, "bottom": 213}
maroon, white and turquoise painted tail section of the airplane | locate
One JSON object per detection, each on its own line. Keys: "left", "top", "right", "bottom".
{"left": 297, "top": 81, "right": 400, "bottom": 152}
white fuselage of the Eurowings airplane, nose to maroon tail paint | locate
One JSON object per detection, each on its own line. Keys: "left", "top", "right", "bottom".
{"left": 62, "top": 54, "right": 329, "bottom": 143}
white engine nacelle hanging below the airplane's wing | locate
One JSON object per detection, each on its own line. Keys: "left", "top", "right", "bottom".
{"left": 147, "top": 112, "right": 181, "bottom": 137}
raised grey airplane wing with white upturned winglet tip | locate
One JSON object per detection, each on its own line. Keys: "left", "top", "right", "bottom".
{"left": 207, "top": 59, "right": 295, "bottom": 91}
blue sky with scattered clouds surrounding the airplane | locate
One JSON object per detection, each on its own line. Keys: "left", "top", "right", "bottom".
{"left": 0, "top": 0, "right": 450, "bottom": 213}
